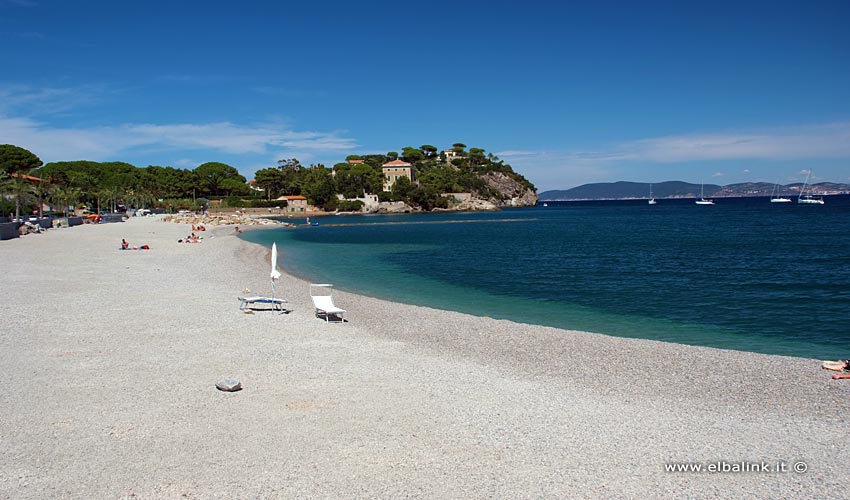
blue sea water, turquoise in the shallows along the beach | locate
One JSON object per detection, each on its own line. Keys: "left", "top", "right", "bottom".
{"left": 244, "top": 197, "right": 850, "bottom": 359}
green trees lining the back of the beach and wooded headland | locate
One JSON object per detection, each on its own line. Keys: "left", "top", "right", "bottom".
{"left": 0, "top": 143, "right": 534, "bottom": 217}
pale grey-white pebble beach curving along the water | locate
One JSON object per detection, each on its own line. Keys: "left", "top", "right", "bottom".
{"left": 0, "top": 218, "right": 850, "bottom": 499}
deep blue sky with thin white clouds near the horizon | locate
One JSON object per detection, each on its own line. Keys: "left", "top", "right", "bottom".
{"left": 0, "top": 0, "right": 850, "bottom": 191}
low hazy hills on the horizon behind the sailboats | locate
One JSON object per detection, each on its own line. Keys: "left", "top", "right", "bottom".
{"left": 539, "top": 181, "right": 850, "bottom": 201}
